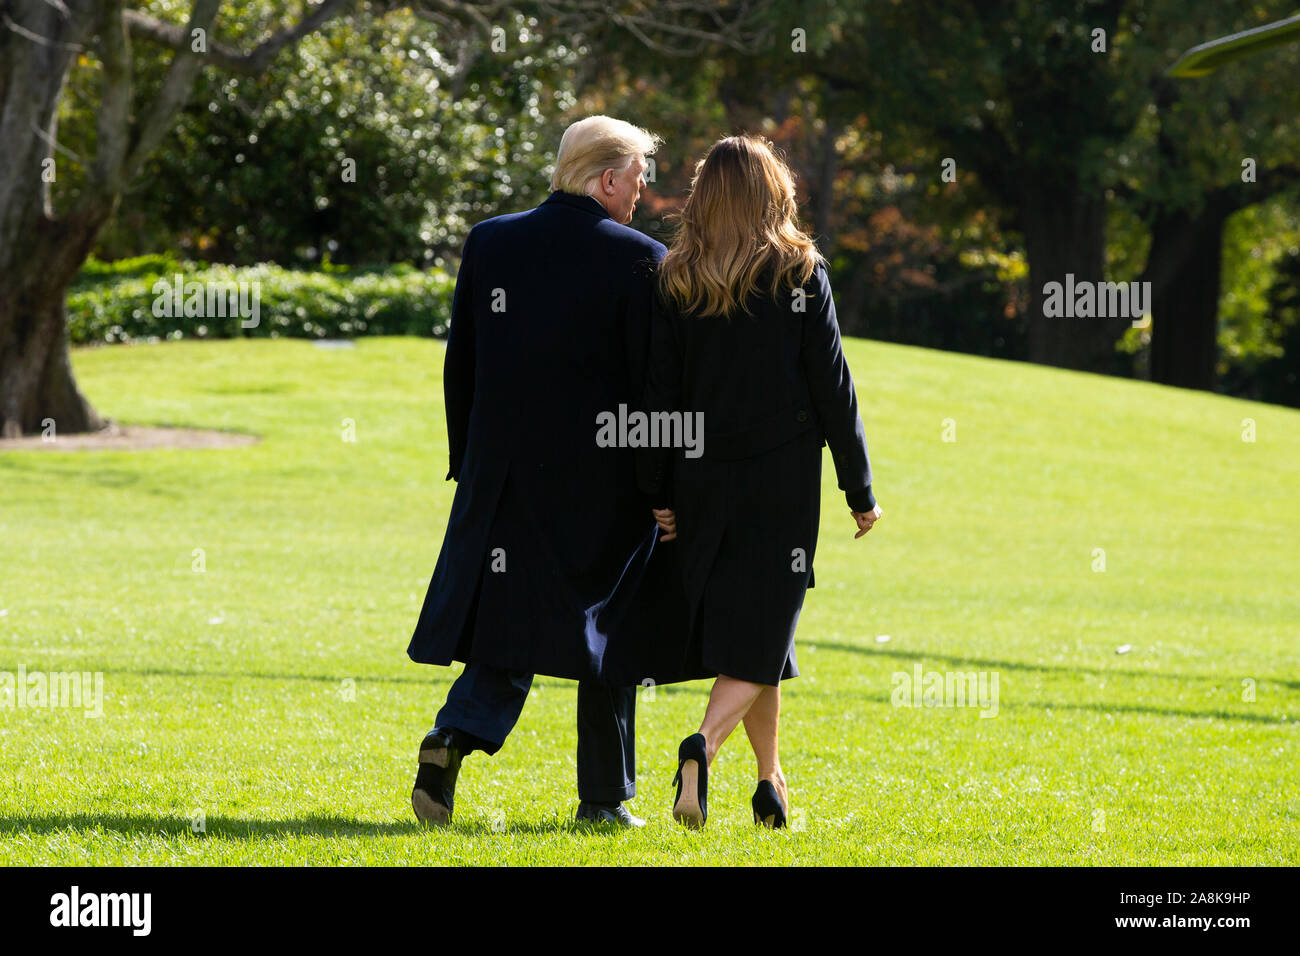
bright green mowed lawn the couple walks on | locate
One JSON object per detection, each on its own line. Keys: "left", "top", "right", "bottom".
{"left": 0, "top": 338, "right": 1300, "bottom": 865}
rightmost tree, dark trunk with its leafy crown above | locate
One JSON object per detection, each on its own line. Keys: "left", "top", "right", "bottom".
{"left": 1118, "top": 8, "right": 1300, "bottom": 390}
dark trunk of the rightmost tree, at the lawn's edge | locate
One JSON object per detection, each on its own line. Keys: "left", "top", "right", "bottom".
{"left": 1143, "top": 204, "right": 1229, "bottom": 392}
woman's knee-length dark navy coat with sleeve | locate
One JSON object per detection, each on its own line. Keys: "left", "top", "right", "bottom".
{"left": 638, "top": 264, "right": 875, "bottom": 684}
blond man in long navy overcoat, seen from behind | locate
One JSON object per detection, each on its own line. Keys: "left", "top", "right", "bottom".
{"left": 408, "top": 116, "right": 684, "bottom": 826}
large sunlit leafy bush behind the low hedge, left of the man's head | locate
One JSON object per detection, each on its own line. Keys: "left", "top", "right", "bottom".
{"left": 69, "top": 3, "right": 579, "bottom": 265}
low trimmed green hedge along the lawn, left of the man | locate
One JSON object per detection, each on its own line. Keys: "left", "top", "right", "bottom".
{"left": 68, "top": 255, "right": 455, "bottom": 345}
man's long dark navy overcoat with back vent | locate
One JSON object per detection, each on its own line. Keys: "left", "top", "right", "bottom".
{"left": 407, "top": 191, "right": 684, "bottom": 683}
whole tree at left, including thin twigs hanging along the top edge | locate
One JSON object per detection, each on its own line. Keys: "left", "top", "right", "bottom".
{"left": 0, "top": 0, "right": 770, "bottom": 437}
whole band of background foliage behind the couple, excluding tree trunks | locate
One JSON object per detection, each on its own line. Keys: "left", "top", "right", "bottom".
{"left": 38, "top": 0, "right": 1300, "bottom": 394}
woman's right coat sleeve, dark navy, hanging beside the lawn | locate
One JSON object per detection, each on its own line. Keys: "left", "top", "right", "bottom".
{"left": 800, "top": 264, "right": 876, "bottom": 511}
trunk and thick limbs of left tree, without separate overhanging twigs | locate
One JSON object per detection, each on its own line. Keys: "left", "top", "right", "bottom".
{"left": 0, "top": 0, "right": 348, "bottom": 437}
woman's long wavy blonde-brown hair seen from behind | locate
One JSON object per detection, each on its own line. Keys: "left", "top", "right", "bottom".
{"left": 659, "top": 135, "right": 822, "bottom": 316}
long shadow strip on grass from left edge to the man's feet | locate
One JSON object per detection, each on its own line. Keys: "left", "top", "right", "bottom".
{"left": 0, "top": 813, "right": 620, "bottom": 840}
